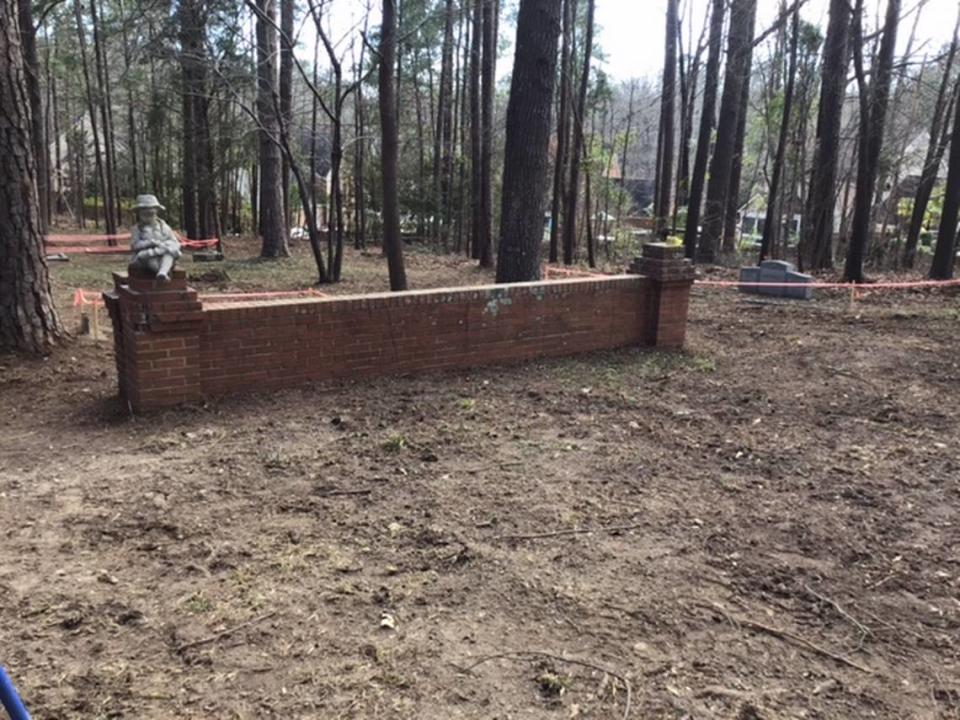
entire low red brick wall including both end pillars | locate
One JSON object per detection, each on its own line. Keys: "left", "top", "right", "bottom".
{"left": 106, "top": 248, "right": 690, "bottom": 411}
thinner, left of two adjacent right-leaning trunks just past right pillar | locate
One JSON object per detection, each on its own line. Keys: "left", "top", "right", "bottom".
{"left": 683, "top": 0, "right": 726, "bottom": 260}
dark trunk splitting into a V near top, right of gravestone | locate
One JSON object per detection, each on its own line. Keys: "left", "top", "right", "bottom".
{"left": 843, "top": 0, "right": 900, "bottom": 282}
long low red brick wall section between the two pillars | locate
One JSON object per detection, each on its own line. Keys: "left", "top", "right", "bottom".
{"left": 200, "top": 275, "right": 647, "bottom": 394}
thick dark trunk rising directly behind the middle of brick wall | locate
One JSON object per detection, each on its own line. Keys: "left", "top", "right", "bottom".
{"left": 497, "top": 0, "right": 561, "bottom": 283}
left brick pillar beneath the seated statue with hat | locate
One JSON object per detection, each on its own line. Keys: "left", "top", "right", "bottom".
{"left": 103, "top": 269, "right": 203, "bottom": 412}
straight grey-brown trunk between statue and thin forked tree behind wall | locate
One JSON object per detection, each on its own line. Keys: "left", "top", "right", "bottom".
{"left": 256, "top": 0, "right": 290, "bottom": 258}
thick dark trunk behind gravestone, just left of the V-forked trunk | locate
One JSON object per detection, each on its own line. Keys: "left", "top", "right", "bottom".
{"left": 798, "top": 0, "right": 851, "bottom": 270}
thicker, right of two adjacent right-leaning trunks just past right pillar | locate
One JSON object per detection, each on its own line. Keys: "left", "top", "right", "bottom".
{"left": 697, "top": 0, "right": 757, "bottom": 262}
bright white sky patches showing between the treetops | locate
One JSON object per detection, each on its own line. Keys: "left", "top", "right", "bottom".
{"left": 310, "top": 0, "right": 958, "bottom": 80}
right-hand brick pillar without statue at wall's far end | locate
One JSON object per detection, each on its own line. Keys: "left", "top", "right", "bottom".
{"left": 630, "top": 243, "right": 694, "bottom": 348}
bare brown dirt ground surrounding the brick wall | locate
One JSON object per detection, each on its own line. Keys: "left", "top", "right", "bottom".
{"left": 0, "top": 245, "right": 960, "bottom": 720}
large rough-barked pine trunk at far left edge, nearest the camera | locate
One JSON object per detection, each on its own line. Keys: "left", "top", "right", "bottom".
{"left": 0, "top": 0, "right": 63, "bottom": 353}
